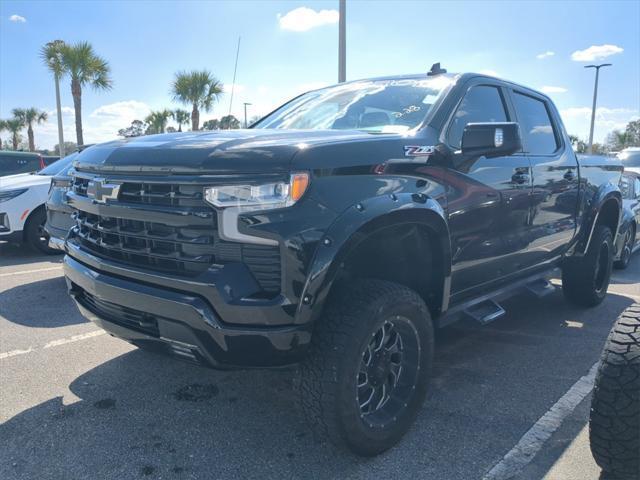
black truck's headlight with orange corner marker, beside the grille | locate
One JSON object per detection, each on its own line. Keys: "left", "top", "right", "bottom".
{"left": 204, "top": 173, "right": 309, "bottom": 210}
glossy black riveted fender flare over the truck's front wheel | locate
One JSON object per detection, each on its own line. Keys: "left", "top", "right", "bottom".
{"left": 296, "top": 193, "right": 451, "bottom": 323}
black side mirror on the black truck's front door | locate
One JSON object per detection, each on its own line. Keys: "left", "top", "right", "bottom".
{"left": 462, "top": 122, "right": 522, "bottom": 157}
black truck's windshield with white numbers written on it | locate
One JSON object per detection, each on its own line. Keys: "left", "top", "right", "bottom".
{"left": 254, "top": 76, "right": 453, "bottom": 133}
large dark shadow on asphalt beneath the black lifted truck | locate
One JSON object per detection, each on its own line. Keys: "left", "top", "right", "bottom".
{"left": 0, "top": 292, "right": 632, "bottom": 480}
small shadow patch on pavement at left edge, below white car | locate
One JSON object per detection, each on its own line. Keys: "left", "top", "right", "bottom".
{"left": 0, "top": 277, "right": 88, "bottom": 328}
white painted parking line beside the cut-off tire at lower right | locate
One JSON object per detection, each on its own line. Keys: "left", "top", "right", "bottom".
{"left": 482, "top": 362, "right": 600, "bottom": 480}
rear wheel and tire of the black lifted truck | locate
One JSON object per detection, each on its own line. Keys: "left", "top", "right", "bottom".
{"left": 562, "top": 225, "right": 613, "bottom": 307}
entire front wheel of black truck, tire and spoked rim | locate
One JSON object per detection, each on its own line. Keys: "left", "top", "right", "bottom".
{"left": 296, "top": 280, "right": 433, "bottom": 456}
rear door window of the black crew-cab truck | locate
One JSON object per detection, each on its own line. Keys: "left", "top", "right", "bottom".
{"left": 513, "top": 92, "right": 558, "bottom": 155}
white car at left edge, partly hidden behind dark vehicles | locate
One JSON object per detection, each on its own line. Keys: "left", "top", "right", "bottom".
{"left": 0, "top": 158, "right": 72, "bottom": 254}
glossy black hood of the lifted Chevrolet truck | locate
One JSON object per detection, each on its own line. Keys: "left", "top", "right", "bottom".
{"left": 75, "top": 129, "right": 384, "bottom": 174}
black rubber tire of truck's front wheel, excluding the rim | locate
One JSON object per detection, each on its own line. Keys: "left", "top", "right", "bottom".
{"left": 294, "top": 279, "right": 433, "bottom": 456}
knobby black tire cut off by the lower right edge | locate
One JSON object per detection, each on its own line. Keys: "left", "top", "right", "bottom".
{"left": 589, "top": 304, "right": 640, "bottom": 480}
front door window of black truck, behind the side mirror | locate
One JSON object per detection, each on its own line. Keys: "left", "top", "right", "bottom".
{"left": 448, "top": 85, "right": 507, "bottom": 148}
